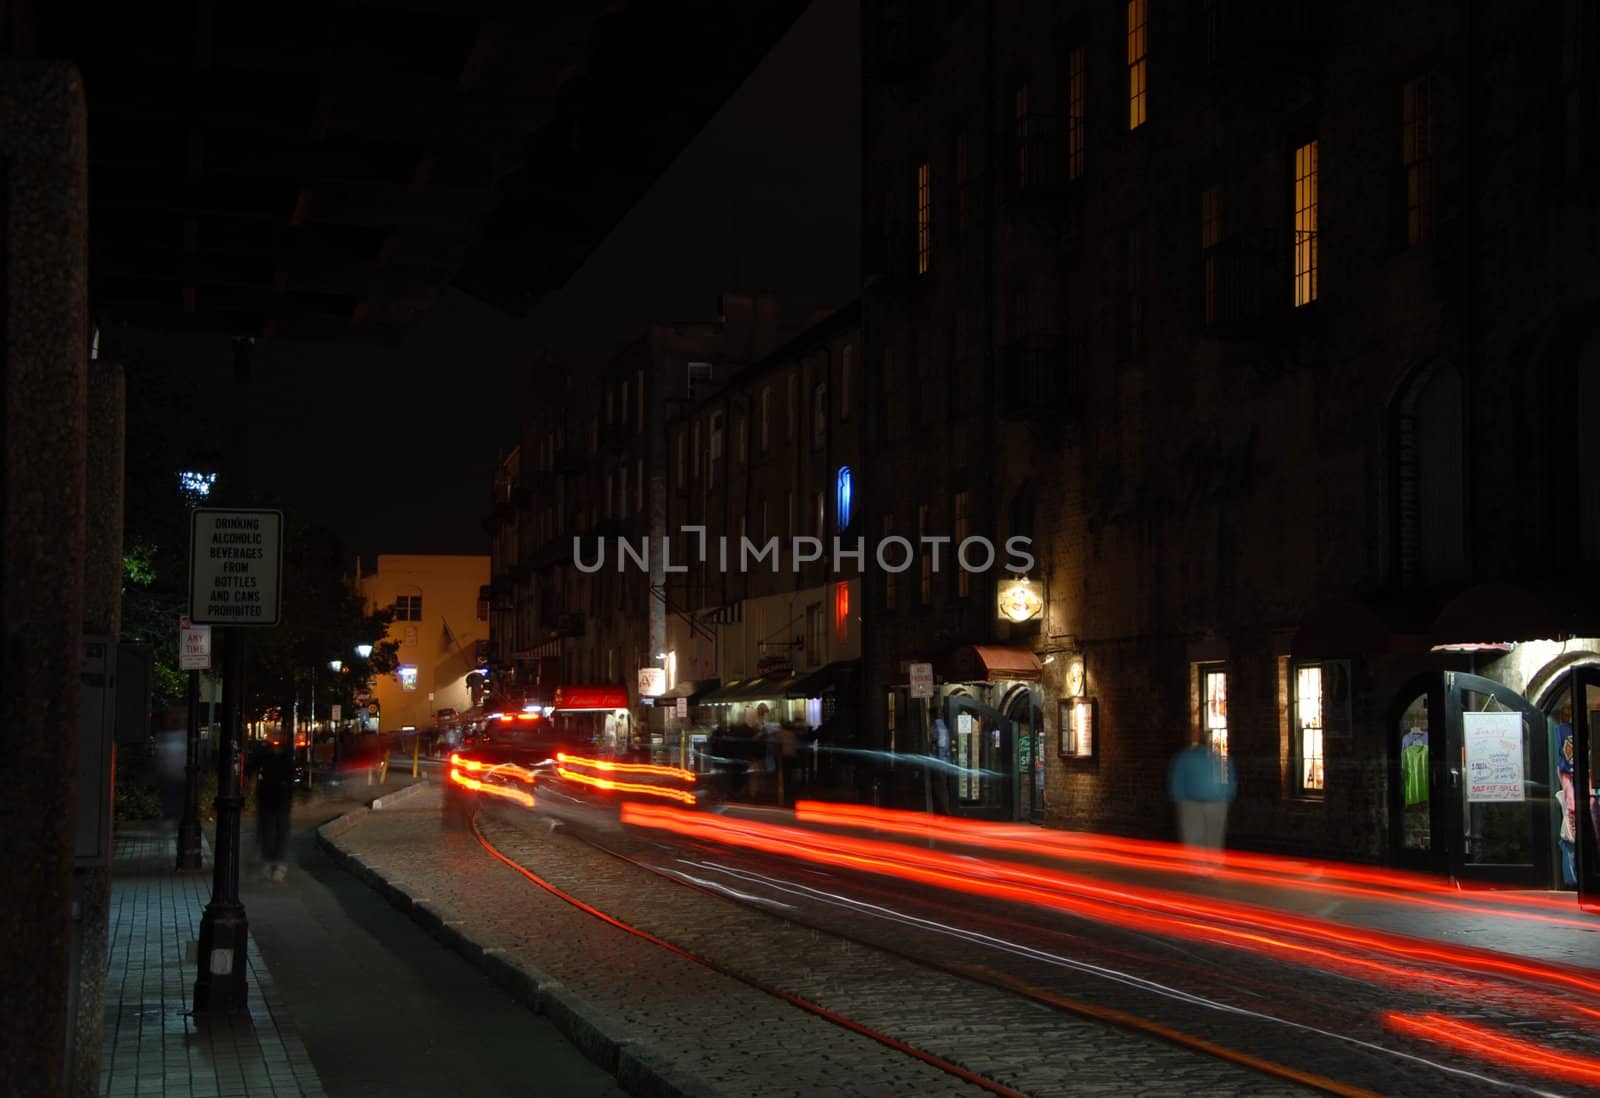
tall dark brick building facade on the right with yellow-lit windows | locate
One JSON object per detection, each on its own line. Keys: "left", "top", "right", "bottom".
{"left": 862, "top": 0, "right": 1600, "bottom": 882}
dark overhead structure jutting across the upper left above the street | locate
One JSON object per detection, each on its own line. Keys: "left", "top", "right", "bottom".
{"left": 34, "top": 0, "right": 805, "bottom": 339}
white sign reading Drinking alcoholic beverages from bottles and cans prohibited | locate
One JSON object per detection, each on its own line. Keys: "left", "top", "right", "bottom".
{"left": 189, "top": 507, "right": 283, "bottom": 626}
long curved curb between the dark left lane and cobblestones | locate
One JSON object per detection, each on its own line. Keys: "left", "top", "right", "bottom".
{"left": 317, "top": 809, "right": 717, "bottom": 1098}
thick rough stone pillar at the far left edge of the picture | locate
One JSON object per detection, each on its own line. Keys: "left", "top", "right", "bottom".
{"left": 0, "top": 61, "right": 90, "bottom": 1096}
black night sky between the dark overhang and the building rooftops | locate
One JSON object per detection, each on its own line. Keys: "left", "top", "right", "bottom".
{"left": 106, "top": 0, "right": 861, "bottom": 567}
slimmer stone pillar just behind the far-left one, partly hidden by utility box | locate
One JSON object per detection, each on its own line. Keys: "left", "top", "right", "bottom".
{"left": 67, "top": 362, "right": 126, "bottom": 1098}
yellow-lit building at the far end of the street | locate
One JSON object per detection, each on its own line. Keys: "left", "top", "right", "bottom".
{"left": 362, "top": 555, "right": 490, "bottom": 731}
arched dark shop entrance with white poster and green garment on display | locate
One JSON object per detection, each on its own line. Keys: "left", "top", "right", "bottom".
{"left": 1389, "top": 671, "right": 1555, "bottom": 888}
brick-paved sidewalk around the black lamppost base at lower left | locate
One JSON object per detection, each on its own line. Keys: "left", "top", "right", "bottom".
{"left": 99, "top": 826, "right": 323, "bottom": 1098}
